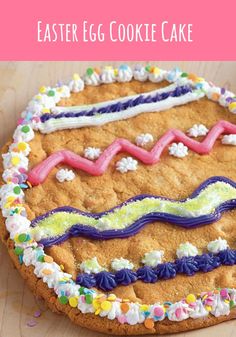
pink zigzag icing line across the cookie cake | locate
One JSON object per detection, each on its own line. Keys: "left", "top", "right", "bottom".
{"left": 28, "top": 120, "right": 236, "bottom": 186}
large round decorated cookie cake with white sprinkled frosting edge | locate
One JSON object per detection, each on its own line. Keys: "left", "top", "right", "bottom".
{"left": 0, "top": 65, "right": 236, "bottom": 335}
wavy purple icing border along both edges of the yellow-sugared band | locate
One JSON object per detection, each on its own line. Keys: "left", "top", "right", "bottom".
{"left": 31, "top": 176, "right": 236, "bottom": 247}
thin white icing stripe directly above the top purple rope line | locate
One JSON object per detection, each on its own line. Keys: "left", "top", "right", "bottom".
{"left": 51, "top": 84, "right": 178, "bottom": 114}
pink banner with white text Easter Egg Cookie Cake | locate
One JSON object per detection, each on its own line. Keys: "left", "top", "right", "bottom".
{"left": 0, "top": 0, "right": 236, "bottom": 61}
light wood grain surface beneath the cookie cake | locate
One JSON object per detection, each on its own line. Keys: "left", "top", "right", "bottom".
{"left": 0, "top": 61, "right": 236, "bottom": 337}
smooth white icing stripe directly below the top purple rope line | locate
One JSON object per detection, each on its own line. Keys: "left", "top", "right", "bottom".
{"left": 34, "top": 91, "right": 205, "bottom": 133}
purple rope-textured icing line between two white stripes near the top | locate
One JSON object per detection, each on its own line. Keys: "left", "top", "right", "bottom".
{"left": 40, "top": 85, "right": 192, "bottom": 123}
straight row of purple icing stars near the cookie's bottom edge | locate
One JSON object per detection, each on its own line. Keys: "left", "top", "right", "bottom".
{"left": 76, "top": 248, "right": 236, "bottom": 291}
